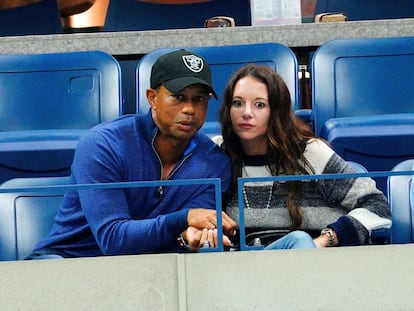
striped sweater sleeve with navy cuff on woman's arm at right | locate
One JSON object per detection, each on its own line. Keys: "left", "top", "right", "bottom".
{"left": 306, "top": 140, "right": 391, "bottom": 245}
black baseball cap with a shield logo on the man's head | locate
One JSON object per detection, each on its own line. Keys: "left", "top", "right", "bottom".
{"left": 151, "top": 49, "right": 218, "bottom": 99}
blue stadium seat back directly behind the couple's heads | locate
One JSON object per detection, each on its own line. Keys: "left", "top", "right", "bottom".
{"left": 136, "top": 43, "right": 299, "bottom": 136}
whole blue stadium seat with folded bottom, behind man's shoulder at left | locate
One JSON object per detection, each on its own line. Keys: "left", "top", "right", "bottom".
{"left": 0, "top": 51, "right": 122, "bottom": 182}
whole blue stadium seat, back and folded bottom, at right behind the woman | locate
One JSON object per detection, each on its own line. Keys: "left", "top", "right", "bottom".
{"left": 311, "top": 37, "right": 414, "bottom": 192}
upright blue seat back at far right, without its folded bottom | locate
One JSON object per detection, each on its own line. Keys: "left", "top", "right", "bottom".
{"left": 311, "top": 36, "right": 414, "bottom": 134}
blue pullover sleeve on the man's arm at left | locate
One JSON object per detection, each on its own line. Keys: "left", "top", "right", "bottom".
{"left": 72, "top": 132, "right": 188, "bottom": 255}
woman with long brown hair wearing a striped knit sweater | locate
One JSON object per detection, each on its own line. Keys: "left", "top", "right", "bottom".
{"left": 215, "top": 64, "right": 391, "bottom": 249}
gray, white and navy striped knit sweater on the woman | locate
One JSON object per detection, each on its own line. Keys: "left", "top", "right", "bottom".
{"left": 220, "top": 139, "right": 391, "bottom": 245}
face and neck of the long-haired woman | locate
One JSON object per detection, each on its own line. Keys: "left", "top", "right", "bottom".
{"left": 230, "top": 76, "right": 270, "bottom": 155}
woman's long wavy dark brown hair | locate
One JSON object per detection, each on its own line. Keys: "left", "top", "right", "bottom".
{"left": 219, "top": 64, "right": 315, "bottom": 229}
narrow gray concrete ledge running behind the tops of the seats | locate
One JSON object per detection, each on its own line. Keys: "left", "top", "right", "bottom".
{"left": 0, "top": 18, "right": 414, "bottom": 55}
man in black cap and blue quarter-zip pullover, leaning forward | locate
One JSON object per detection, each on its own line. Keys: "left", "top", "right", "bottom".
{"left": 28, "top": 50, "right": 236, "bottom": 259}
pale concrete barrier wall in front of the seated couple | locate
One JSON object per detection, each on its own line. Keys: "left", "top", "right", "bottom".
{"left": 0, "top": 245, "right": 414, "bottom": 311}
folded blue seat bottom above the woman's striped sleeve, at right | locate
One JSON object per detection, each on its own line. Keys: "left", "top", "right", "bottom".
{"left": 321, "top": 113, "right": 414, "bottom": 183}
